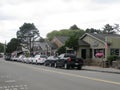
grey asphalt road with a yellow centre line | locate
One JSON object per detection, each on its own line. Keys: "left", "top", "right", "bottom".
{"left": 0, "top": 59, "right": 120, "bottom": 90}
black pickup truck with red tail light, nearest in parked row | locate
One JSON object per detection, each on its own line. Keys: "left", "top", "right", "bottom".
{"left": 54, "top": 53, "right": 83, "bottom": 69}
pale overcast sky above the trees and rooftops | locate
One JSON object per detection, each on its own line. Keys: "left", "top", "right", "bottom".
{"left": 0, "top": 0, "right": 120, "bottom": 43}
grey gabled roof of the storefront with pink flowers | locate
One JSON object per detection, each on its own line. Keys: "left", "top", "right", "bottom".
{"left": 81, "top": 33, "right": 120, "bottom": 42}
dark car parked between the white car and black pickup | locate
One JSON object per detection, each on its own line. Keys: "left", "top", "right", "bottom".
{"left": 44, "top": 56, "right": 58, "bottom": 67}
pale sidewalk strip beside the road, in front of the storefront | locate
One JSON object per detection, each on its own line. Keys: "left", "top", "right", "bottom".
{"left": 82, "top": 66, "right": 120, "bottom": 74}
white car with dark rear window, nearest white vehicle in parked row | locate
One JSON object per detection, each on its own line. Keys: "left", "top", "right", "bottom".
{"left": 32, "top": 55, "right": 47, "bottom": 64}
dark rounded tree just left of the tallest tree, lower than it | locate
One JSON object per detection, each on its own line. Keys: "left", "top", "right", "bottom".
{"left": 6, "top": 38, "right": 20, "bottom": 53}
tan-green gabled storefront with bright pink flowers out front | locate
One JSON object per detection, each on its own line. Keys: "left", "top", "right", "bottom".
{"left": 77, "top": 33, "right": 120, "bottom": 66}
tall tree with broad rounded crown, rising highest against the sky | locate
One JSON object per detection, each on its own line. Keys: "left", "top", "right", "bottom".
{"left": 16, "top": 23, "right": 39, "bottom": 51}
